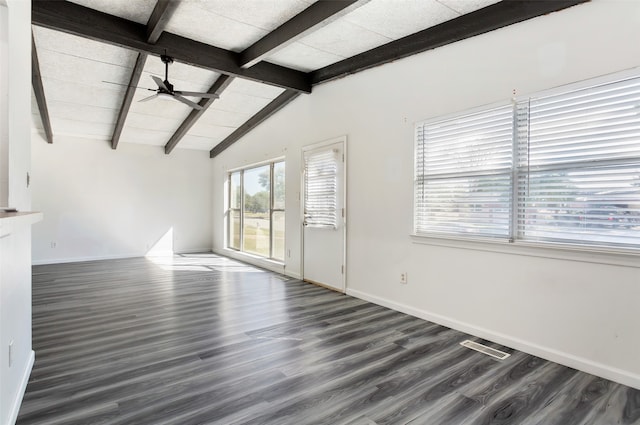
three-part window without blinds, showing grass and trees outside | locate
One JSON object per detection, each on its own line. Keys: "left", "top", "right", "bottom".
{"left": 227, "top": 162, "right": 285, "bottom": 261}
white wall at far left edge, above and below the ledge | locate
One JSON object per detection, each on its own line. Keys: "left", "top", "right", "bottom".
{"left": 0, "top": 0, "right": 34, "bottom": 425}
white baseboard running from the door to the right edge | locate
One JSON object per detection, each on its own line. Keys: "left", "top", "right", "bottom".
{"left": 347, "top": 288, "right": 640, "bottom": 389}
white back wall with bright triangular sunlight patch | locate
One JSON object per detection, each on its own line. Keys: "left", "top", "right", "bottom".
{"left": 32, "top": 135, "right": 212, "bottom": 264}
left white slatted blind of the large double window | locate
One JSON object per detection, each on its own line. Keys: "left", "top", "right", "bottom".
{"left": 415, "top": 104, "right": 513, "bottom": 238}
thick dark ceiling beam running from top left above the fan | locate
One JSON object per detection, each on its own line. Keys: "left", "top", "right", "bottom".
{"left": 31, "top": 0, "right": 311, "bottom": 93}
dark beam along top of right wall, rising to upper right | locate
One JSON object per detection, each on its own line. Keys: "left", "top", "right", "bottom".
{"left": 311, "top": 0, "right": 589, "bottom": 85}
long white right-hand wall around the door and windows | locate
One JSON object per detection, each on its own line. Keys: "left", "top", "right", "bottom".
{"left": 213, "top": 0, "right": 640, "bottom": 388}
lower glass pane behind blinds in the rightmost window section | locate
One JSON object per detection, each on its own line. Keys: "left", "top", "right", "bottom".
{"left": 518, "top": 165, "right": 640, "bottom": 246}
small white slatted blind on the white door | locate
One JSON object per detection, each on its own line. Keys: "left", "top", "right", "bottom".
{"left": 304, "top": 149, "right": 338, "bottom": 228}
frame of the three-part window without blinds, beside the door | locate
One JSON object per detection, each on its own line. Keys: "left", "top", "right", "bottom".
{"left": 225, "top": 158, "right": 286, "bottom": 264}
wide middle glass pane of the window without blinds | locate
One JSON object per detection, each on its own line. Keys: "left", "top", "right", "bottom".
{"left": 242, "top": 165, "right": 270, "bottom": 257}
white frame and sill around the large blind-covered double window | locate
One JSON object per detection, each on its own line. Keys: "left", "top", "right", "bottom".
{"left": 411, "top": 68, "right": 640, "bottom": 256}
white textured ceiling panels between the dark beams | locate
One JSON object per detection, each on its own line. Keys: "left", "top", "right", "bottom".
{"left": 32, "top": 0, "right": 498, "bottom": 151}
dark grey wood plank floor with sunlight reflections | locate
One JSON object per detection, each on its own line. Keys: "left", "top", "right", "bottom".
{"left": 18, "top": 254, "right": 640, "bottom": 425}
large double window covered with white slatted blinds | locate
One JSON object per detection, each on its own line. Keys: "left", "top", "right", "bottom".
{"left": 415, "top": 69, "right": 640, "bottom": 248}
